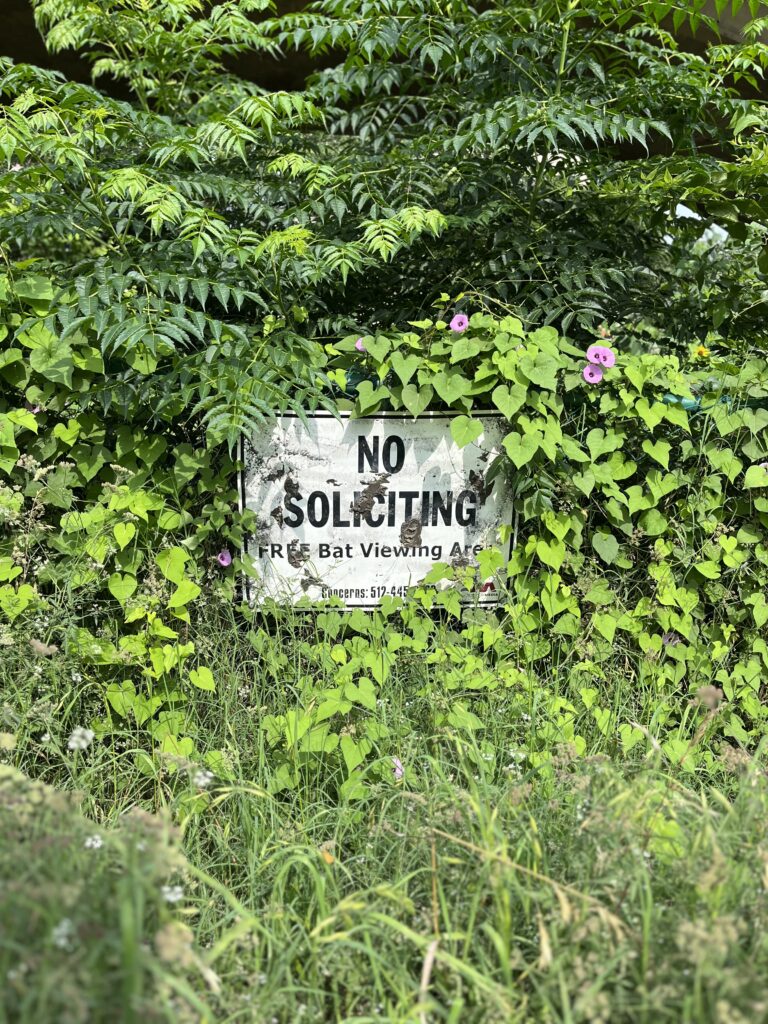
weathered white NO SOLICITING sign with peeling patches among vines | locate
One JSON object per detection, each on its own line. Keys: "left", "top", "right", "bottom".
{"left": 241, "top": 413, "right": 510, "bottom": 608}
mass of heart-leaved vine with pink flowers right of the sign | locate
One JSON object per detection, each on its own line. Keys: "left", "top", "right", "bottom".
{"left": 321, "top": 311, "right": 768, "bottom": 770}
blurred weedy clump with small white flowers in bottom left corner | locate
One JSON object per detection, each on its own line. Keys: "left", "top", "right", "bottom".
{"left": 0, "top": 765, "right": 218, "bottom": 1024}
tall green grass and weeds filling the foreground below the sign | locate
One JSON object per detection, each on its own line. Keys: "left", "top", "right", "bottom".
{"left": 0, "top": 610, "right": 768, "bottom": 1024}
